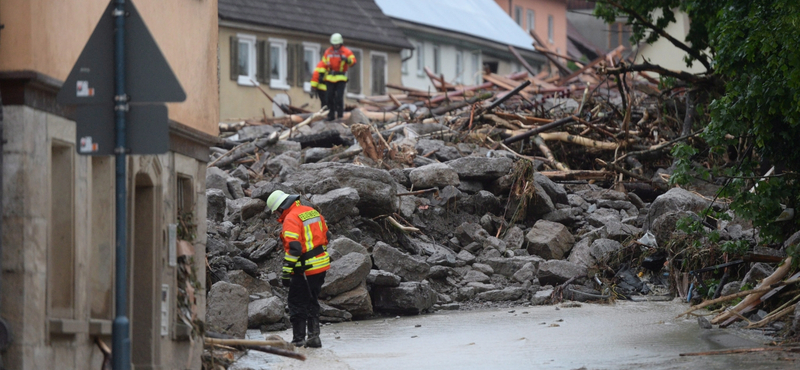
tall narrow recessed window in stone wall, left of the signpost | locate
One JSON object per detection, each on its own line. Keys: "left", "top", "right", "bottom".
{"left": 47, "top": 141, "right": 75, "bottom": 319}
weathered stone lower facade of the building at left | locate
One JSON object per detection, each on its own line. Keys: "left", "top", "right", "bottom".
{"left": 0, "top": 106, "right": 206, "bottom": 370}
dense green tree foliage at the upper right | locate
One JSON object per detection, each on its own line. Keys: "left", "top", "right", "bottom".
{"left": 595, "top": 0, "right": 800, "bottom": 255}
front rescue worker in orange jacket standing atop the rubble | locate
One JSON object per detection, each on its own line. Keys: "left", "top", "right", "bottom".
{"left": 322, "top": 33, "right": 356, "bottom": 121}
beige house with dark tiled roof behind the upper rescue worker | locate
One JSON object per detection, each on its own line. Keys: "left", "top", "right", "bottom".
{"left": 219, "top": 0, "right": 412, "bottom": 121}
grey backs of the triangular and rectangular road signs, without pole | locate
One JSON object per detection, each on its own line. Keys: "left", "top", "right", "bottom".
{"left": 56, "top": 0, "right": 186, "bottom": 155}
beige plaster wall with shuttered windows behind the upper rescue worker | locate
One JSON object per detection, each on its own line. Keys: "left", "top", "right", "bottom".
{"left": 219, "top": 26, "right": 402, "bottom": 122}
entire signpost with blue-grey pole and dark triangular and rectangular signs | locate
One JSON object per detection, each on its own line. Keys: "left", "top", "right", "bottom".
{"left": 56, "top": 0, "right": 186, "bottom": 370}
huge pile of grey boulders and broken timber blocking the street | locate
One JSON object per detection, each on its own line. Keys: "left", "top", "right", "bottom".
{"left": 206, "top": 43, "right": 794, "bottom": 358}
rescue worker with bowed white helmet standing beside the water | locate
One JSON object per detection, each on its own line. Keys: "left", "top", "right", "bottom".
{"left": 267, "top": 190, "right": 331, "bottom": 348}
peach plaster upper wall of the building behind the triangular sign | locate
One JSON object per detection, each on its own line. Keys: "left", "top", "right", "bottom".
{"left": 0, "top": 0, "right": 219, "bottom": 135}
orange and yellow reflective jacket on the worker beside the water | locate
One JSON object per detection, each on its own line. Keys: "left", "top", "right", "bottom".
{"left": 278, "top": 200, "right": 331, "bottom": 275}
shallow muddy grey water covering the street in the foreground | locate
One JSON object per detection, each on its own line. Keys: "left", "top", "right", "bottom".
{"left": 234, "top": 302, "right": 798, "bottom": 370}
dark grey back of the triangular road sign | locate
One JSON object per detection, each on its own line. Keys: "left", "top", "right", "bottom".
{"left": 56, "top": 0, "right": 186, "bottom": 105}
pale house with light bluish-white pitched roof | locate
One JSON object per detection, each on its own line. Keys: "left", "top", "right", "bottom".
{"left": 375, "top": 0, "right": 545, "bottom": 91}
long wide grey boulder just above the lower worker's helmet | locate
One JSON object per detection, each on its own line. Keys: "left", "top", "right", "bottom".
{"left": 286, "top": 162, "right": 397, "bottom": 217}
